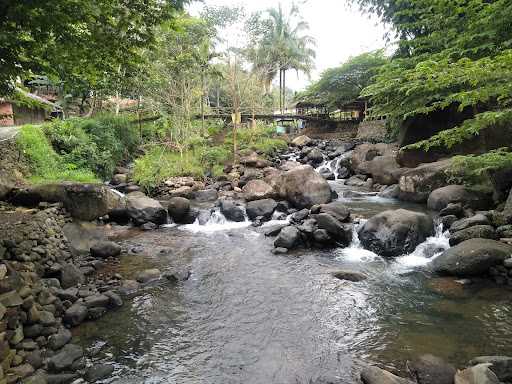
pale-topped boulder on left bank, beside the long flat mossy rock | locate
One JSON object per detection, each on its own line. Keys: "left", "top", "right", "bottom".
{"left": 126, "top": 192, "right": 167, "bottom": 225}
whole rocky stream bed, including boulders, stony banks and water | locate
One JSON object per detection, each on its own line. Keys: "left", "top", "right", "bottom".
{"left": 0, "top": 137, "right": 512, "bottom": 384}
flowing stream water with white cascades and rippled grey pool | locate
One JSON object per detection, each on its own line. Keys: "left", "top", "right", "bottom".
{"left": 76, "top": 158, "right": 512, "bottom": 384}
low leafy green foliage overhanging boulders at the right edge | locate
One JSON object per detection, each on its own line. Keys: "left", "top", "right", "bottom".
{"left": 448, "top": 148, "right": 512, "bottom": 190}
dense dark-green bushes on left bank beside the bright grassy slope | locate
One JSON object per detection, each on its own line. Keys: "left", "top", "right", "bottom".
{"left": 43, "top": 115, "right": 139, "bottom": 179}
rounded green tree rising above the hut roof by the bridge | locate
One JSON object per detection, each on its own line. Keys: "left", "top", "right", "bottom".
{"left": 296, "top": 50, "right": 388, "bottom": 108}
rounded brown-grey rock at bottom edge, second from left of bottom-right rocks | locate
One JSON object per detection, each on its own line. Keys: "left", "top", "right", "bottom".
{"left": 407, "top": 355, "right": 457, "bottom": 384}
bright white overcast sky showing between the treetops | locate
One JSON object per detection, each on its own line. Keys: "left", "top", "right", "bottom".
{"left": 189, "top": 0, "right": 386, "bottom": 90}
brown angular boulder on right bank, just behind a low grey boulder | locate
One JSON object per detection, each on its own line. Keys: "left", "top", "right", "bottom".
{"left": 399, "top": 159, "right": 452, "bottom": 203}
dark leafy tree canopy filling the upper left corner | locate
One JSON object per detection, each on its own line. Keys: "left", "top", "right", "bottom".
{"left": 0, "top": 0, "right": 186, "bottom": 94}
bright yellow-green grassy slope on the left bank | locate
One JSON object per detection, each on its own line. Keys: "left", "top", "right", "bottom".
{"left": 17, "top": 125, "right": 98, "bottom": 183}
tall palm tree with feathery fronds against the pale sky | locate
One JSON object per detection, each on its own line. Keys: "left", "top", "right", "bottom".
{"left": 250, "top": 4, "right": 315, "bottom": 113}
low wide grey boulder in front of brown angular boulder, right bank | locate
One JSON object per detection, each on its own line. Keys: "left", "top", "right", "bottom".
{"left": 427, "top": 185, "right": 492, "bottom": 211}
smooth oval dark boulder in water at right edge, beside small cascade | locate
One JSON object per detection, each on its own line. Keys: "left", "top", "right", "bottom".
{"left": 432, "top": 239, "right": 512, "bottom": 277}
